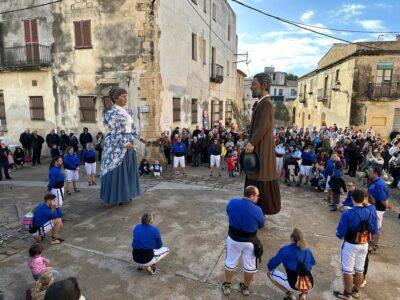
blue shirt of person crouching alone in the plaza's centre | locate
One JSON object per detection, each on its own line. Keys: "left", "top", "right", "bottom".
{"left": 132, "top": 224, "right": 162, "bottom": 250}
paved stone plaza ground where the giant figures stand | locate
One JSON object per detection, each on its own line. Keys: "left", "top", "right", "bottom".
{"left": 0, "top": 164, "right": 400, "bottom": 300}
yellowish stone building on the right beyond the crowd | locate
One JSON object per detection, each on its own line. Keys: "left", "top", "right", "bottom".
{"left": 292, "top": 37, "right": 400, "bottom": 136}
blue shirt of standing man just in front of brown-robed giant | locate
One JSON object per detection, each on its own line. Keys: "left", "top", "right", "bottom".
{"left": 226, "top": 198, "right": 265, "bottom": 232}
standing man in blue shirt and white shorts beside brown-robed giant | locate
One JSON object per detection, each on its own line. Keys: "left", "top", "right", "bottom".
{"left": 222, "top": 185, "right": 265, "bottom": 296}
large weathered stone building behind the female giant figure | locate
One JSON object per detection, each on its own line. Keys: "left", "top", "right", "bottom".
{"left": 0, "top": 0, "right": 237, "bottom": 153}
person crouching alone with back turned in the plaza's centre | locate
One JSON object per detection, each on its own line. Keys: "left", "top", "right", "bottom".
{"left": 132, "top": 213, "right": 169, "bottom": 275}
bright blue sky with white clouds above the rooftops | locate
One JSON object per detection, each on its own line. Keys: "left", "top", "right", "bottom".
{"left": 228, "top": 0, "right": 400, "bottom": 76}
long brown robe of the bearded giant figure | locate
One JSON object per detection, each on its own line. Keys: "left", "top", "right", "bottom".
{"left": 245, "top": 97, "right": 281, "bottom": 215}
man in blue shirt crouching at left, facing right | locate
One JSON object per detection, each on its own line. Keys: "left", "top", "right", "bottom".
{"left": 29, "top": 194, "right": 63, "bottom": 245}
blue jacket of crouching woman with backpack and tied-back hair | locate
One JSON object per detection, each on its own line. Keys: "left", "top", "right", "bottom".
{"left": 267, "top": 243, "right": 315, "bottom": 271}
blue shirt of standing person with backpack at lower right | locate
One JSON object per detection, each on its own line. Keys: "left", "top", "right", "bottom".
{"left": 336, "top": 206, "right": 377, "bottom": 239}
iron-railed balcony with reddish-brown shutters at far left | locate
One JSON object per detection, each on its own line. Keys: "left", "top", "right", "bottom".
{"left": 0, "top": 44, "right": 51, "bottom": 69}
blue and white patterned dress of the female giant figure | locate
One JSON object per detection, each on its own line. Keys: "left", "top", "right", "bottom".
{"left": 100, "top": 105, "right": 140, "bottom": 204}
